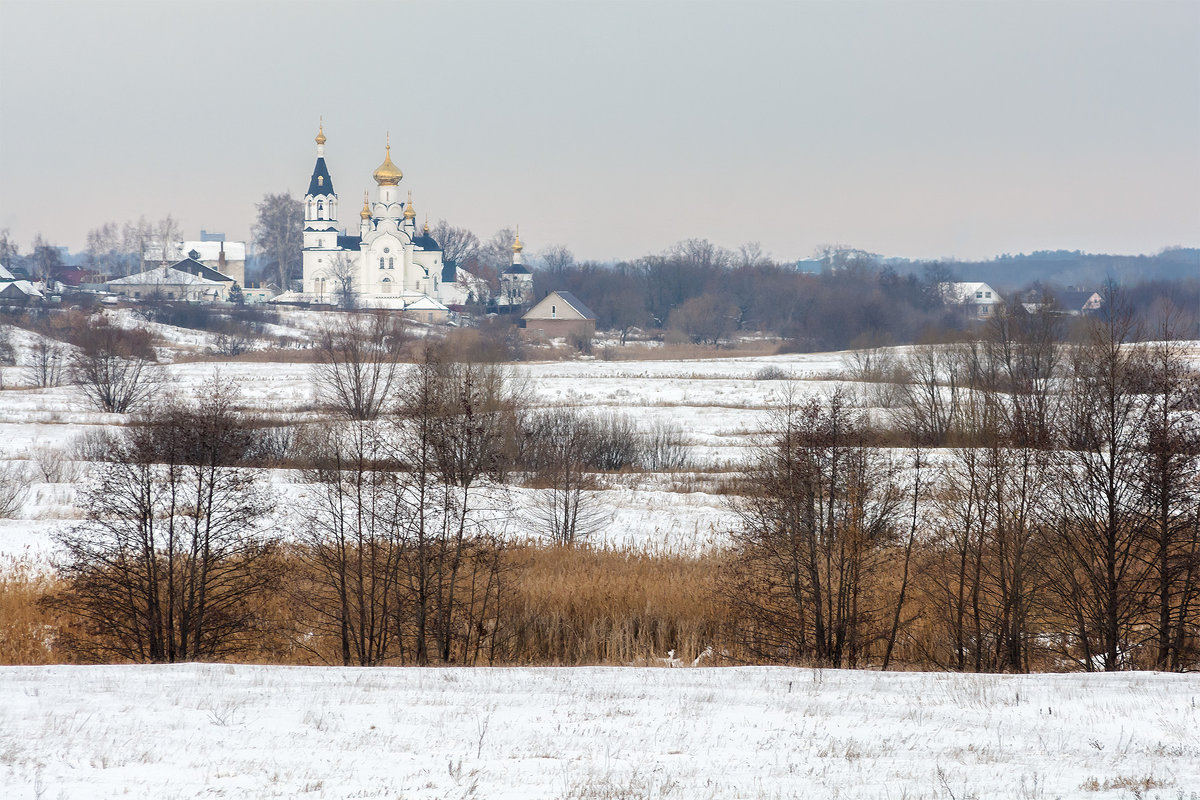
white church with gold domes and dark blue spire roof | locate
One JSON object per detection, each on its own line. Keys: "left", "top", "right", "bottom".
{"left": 287, "top": 125, "right": 478, "bottom": 311}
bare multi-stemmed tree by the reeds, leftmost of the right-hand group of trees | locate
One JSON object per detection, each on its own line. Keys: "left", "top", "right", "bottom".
{"left": 728, "top": 391, "right": 902, "bottom": 667}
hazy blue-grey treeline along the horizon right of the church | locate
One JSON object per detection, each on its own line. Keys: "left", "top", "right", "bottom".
{"left": 520, "top": 240, "right": 1200, "bottom": 351}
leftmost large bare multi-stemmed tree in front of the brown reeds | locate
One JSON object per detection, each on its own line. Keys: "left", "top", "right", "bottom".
{"left": 49, "top": 380, "right": 277, "bottom": 662}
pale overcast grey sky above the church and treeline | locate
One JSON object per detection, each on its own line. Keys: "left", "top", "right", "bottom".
{"left": 0, "top": 0, "right": 1200, "bottom": 259}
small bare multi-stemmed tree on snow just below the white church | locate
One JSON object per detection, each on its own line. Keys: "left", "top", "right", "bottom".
{"left": 313, "top": 313, "right": 406, "bottom": 420}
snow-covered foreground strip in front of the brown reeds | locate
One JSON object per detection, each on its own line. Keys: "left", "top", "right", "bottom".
{"left": 0, "top": 664, "right": 1200, "bottom": 800}
